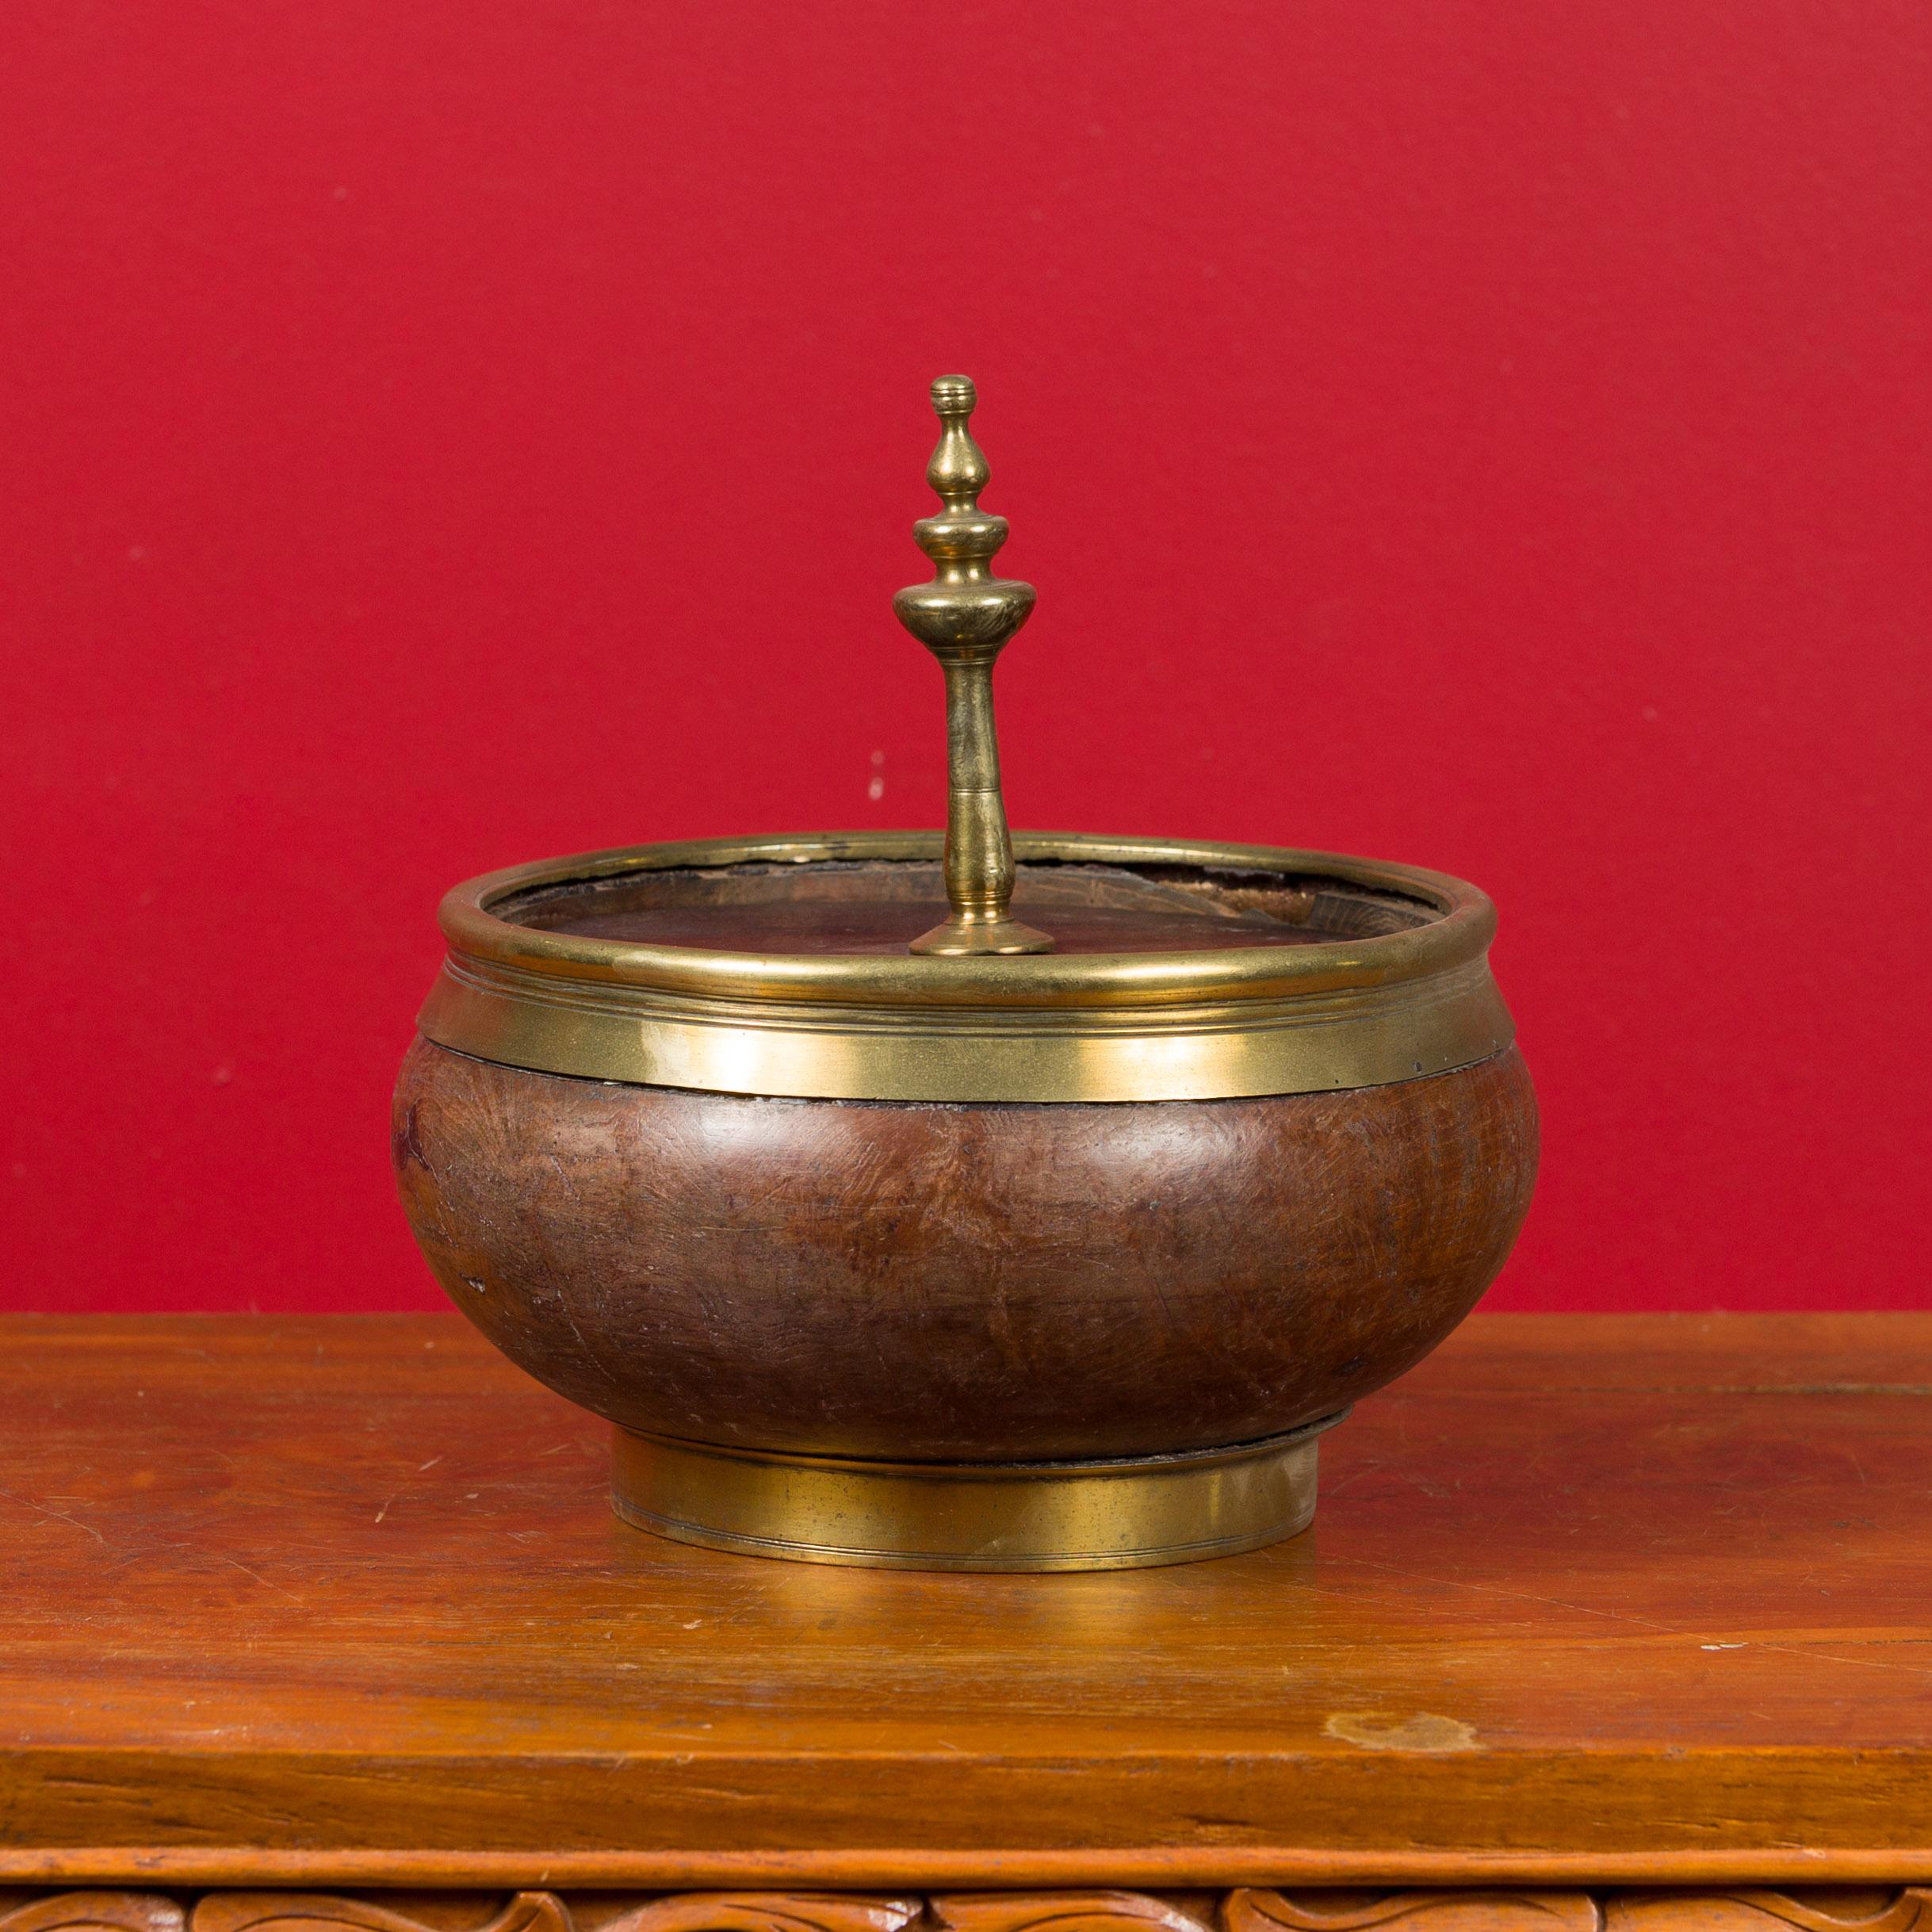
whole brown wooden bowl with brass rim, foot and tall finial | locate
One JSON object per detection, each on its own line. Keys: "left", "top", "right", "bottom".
{"left": 394, "top": 377, "right": 1536, "bottom": 1570}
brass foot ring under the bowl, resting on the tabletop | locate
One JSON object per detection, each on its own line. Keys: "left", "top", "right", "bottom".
{"left": 610, "top": 1410, "right": 1347, "bottom": 1570}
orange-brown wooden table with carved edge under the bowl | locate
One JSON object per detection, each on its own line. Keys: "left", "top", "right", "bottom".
{"left": 0, "top": 1316, "right": 1932, "bottom": 1932}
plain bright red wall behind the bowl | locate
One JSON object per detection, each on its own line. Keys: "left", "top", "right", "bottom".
{"left": 0, "top": 0, "right": 1932, "bottom": 1308}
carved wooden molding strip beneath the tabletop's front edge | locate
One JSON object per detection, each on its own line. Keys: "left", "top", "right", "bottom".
{"left": 0, "top": 1886, "right": 1932, "bottom": 1932}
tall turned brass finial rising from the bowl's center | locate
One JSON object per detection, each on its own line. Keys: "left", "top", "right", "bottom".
{"left": 893, "top": 375, "right": 1053, "bottom": 955}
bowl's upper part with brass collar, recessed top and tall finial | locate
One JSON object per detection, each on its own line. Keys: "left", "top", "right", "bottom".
{"left": 419, "top": 377, "right": 1513, "bottom": 1101}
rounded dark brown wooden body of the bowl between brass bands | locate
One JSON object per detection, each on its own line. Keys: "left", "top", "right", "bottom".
{"left": 394, "top": 1039, "right": 1536, "bottom": 1460}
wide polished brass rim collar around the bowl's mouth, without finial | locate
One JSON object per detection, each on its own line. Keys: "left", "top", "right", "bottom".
{"left": 419, "top": 832, "right": 1515, "bottom": 1104}
